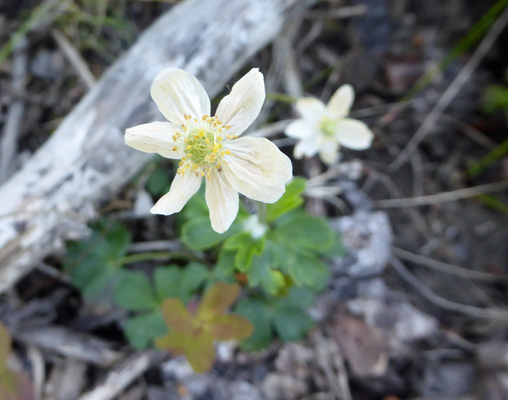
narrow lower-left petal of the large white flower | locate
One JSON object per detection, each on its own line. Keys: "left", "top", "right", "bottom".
{"left": 150, "top": 171, "right": 201, "bottom": 215}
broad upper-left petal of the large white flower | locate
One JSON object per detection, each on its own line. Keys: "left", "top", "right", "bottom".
{"left": 150, "top": 68, "right": 210, "bottom": 125}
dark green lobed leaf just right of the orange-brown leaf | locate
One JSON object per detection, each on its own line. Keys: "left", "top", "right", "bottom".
{"left": 235, "top": 287, "right": 314, "bottom": 350}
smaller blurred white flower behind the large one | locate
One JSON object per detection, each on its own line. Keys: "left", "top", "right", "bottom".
{"left": 286, "top": 85, "right": 374, "bottom": 164}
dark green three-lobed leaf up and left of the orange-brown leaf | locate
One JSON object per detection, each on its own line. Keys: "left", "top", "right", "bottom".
{"left": 115, "top": 263, "right": 208, "bottom": 349}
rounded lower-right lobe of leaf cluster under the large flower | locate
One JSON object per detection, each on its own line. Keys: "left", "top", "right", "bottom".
{"left": 288, "top": 251, "right": 330, "bottom": 291}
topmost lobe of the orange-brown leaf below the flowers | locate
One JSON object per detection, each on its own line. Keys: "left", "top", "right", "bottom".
{"left": 198, "top": 282, "right": 240, "bottom": 320}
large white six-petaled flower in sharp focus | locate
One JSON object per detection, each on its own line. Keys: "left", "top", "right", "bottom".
{"left": 125, "top": 68, "right": 292, "bottom": 233}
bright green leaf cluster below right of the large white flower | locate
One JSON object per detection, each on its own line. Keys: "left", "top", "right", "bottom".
{"left": 217, "top": 178, "right": 343, "bottom": 295}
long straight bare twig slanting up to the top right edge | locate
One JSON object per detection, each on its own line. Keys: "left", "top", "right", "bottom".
{"left": 389, "top": 8, "right": 508, "bottom": 172}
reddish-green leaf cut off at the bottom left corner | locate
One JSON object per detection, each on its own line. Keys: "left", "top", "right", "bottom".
{"left": 0, "top": 322, "right": 35, "bottom": 400}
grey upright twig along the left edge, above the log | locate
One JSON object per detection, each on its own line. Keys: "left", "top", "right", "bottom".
{"left": 0, "top": 40, "right": 28, "bottom": 184}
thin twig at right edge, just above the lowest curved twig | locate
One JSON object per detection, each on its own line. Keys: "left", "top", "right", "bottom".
{"left": 392, "top": 247, "right": 508, "bottom": 282}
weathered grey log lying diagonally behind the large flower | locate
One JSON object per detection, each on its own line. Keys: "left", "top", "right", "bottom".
{"left": 0, "top": 0, "right": 315, "bottom": 292}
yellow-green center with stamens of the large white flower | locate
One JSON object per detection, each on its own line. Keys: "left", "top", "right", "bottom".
{"left": 173, "top": 115, "right": 237, "bottom": 177}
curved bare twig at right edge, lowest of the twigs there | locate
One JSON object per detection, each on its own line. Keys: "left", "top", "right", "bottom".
{"left": 390, "top": 257, "right": 508, "bottom": 321}
